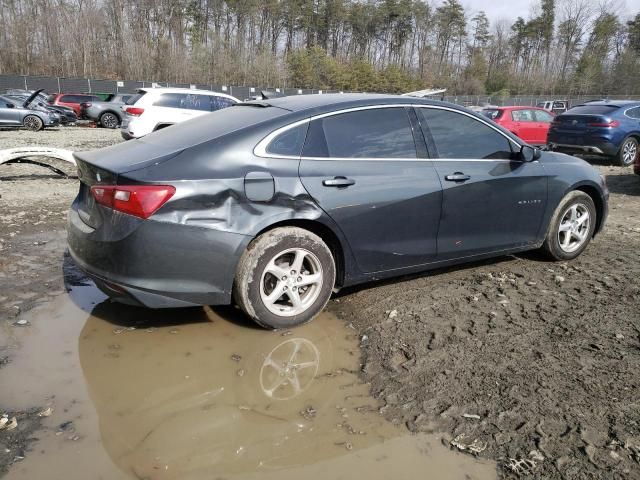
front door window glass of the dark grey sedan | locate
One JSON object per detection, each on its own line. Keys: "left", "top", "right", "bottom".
{"left": 416, "top": 108, "right": 513, "bottom": 159}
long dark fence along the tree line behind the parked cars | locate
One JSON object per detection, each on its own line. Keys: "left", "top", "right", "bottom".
{"left": 0, "top": 75, "right": 632, "bottom": 106}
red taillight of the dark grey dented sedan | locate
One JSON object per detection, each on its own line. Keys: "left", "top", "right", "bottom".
{"left": 91, "top": 185, "right": 176, "bottom": 218}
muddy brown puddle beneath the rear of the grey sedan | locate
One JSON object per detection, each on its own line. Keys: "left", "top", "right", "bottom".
{"left": 0, "top": 286, "right": 496, "bottom": 480}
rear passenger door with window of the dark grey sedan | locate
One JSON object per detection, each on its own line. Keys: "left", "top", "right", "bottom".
{"left": 299, "top": 106, "right": 442, "bottom": 272}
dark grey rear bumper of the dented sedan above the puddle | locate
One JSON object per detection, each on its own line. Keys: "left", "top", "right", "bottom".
{"left": 67, "top": 206, "right": 251, "bottom": 308}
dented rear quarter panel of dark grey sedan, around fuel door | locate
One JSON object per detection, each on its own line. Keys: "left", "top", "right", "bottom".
{"left": 119, "top": 124, "right": 353, "bottom": 286}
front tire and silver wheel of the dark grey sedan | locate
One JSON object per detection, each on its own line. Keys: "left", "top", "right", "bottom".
{"left": 542, "top": 191, "right": 597, "bottom": 260}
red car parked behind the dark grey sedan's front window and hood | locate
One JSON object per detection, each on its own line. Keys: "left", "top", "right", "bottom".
{"left": 482, "top": 107, "right": 554, "bottom": 145}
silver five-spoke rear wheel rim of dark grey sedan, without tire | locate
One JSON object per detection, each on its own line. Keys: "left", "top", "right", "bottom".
{"left": 260, "top": 248, "right": 323, "bottom": 317}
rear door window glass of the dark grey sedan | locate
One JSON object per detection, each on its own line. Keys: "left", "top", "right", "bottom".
{"left": 304, "top": 108, "right": 416, "bottom": 158}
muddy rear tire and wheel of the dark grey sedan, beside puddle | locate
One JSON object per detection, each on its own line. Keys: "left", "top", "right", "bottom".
{"left": 234, "top": 227, "right": 336, "bottom": 329}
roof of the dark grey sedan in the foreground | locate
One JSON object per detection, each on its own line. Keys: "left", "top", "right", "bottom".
{"left": 238, "top": 93, "right": 466, "bottom": 113}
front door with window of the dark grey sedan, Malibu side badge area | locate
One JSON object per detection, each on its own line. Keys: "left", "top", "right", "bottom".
{"left": 416, "top": 106, "right": 547, "bottom": 260}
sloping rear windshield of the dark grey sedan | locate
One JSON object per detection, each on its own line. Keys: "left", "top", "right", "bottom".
{"left": 139, "top": 103, "right": 290, "bottom": 149}
